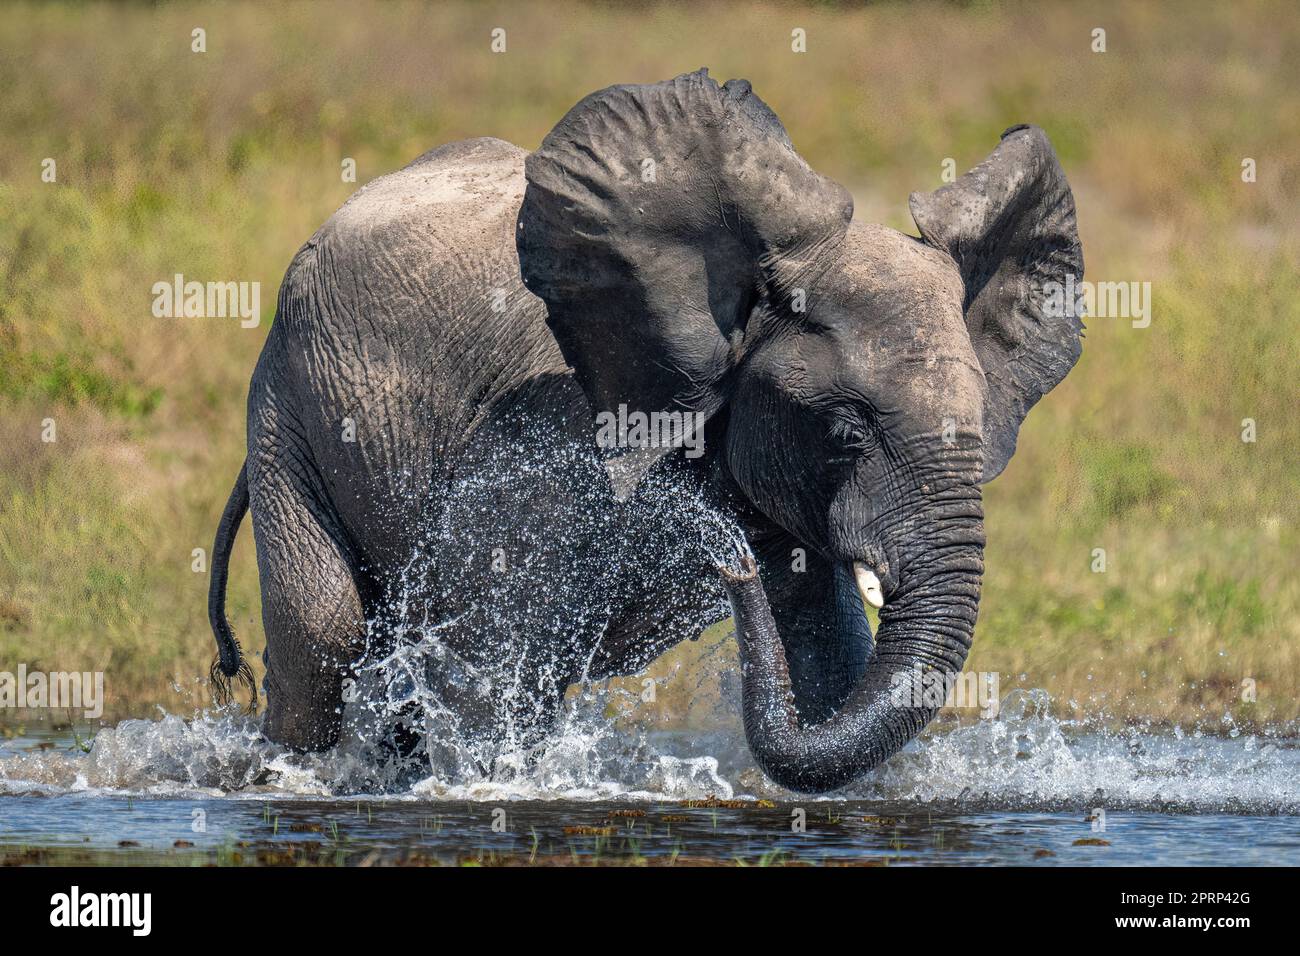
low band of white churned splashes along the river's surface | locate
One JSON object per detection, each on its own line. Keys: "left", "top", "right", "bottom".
{"left": 0, "top": 688, "right": 1300, "bottom": 816}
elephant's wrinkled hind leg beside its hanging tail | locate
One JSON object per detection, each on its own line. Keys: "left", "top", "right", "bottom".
{"left": 248, "top": 434, "right": 365, "bottom": 750}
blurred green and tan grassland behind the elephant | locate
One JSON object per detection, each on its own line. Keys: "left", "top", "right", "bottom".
{"left": 0, "top": 1, "right": 1300, "bottom": 731}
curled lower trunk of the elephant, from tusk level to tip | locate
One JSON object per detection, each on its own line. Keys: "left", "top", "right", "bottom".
{"left": 722, "top": 529, "right": 983, "bottom": 792}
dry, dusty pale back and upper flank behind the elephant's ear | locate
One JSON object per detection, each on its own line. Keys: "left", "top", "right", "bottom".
{"left": 258, "top": 138, "right": 581, "bottom": 572}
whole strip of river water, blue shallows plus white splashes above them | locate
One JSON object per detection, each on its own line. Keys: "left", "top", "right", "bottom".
{"left": 0, "top": 693, "right": 1300, "bottom": 866}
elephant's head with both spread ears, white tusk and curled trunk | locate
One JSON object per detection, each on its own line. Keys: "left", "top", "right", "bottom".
{"left": 517, "top": 70, "right": 1083, "bottom": 790}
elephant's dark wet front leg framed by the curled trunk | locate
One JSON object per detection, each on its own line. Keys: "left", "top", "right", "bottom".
{"left": 749, "top": 528, "right": 872, "bottom": 726}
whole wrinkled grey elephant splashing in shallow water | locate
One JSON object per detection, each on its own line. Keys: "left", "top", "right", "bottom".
{"left": 212, "top": 70, "right": 1083, "bottom": 791}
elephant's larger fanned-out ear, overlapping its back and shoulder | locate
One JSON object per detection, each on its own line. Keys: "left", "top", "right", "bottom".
{"left": 516, "top": 70, "right": 853, "bottom": 494}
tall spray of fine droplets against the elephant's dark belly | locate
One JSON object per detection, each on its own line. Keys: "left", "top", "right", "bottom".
{"left": 323, "top": 415, "right": 748, "bottom": 790}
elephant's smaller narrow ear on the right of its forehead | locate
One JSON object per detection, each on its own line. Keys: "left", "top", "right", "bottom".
{"left": 909, "top": 126, "right": 1083, "bottom": 481}
